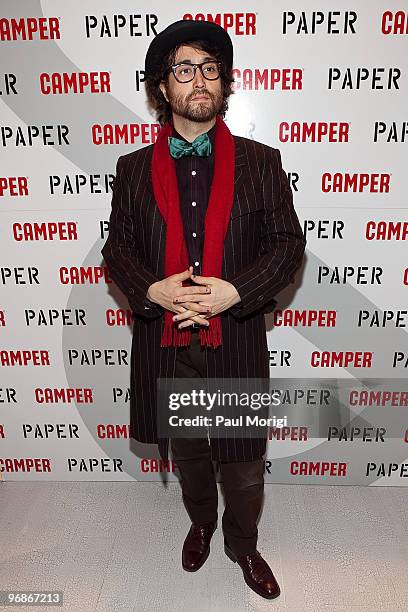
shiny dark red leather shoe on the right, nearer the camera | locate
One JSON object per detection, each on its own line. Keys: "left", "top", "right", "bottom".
{"left": 224, "top": 542, "right": 280, "bottom": 599}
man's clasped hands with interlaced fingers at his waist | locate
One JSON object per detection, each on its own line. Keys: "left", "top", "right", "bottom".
{"left": 147, "top": 266, "right": 241, "bottom": 329}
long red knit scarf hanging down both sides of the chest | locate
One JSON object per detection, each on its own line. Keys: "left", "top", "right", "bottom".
{"left": 152, "top": 116, "right": 235, "bottom": 348}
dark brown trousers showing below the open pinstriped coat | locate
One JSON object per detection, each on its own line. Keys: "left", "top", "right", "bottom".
{"left": 171, "top": 331, "right": 264, "bottom": 555}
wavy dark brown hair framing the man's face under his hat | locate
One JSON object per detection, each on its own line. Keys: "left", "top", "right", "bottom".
{"left": 145, "top": 40, "right": 234, "bottom": 125}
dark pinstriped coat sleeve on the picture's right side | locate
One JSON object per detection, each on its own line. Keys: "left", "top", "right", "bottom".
{"left": 228, "top": 147, "right": 306, "bottom": 319}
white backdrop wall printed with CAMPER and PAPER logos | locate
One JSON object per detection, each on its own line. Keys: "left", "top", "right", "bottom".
{"left": 0, "top": 0, "right": 408, "bottom": 486}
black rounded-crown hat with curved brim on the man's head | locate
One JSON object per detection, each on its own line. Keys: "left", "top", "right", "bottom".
{"left": 145, "top": 19, "right": 233, "bottom": 78}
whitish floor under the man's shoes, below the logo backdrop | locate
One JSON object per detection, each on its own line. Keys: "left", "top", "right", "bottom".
{"left": 0, "top": 482, "right": 408, "bottom": 612}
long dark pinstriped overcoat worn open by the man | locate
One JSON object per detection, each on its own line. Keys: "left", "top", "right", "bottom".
{"left": 102, "top": 136, "right": 306, "bottom": 461}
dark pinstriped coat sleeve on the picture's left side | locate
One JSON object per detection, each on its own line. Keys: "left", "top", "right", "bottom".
{"left": 101, "top": 157, "right": 164, "bottom": 319}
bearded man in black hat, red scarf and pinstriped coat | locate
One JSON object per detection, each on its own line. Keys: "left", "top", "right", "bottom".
{"left": 102, "top": 20, "right": 306, "bottom": 599}
